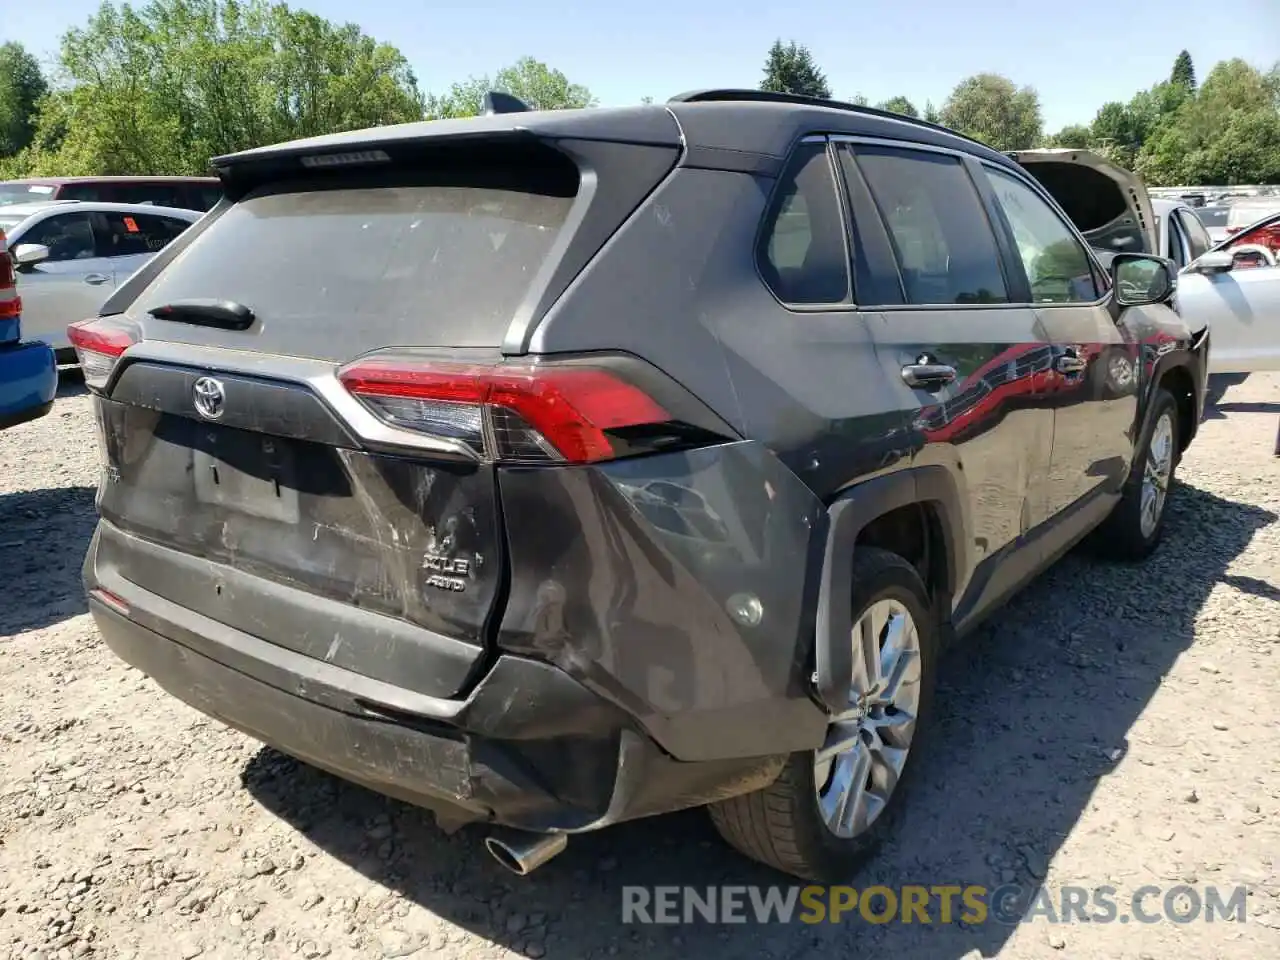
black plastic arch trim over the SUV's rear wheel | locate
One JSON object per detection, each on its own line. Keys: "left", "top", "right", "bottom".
{"left": 814, "top": 465, "right": 964, "bottom": 712}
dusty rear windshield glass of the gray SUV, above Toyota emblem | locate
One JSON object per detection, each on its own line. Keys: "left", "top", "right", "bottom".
{"left": 129, "top": 165, "right": 577, "bottom": 360}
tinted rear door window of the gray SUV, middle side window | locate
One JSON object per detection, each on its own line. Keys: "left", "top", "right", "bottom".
{"left": 855, "top": 146, "right": 1009, "bottom": 303}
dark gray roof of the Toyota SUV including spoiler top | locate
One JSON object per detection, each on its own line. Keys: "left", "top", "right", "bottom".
{"left": 212, "top": 91, "right": 1016, "bottom": 174}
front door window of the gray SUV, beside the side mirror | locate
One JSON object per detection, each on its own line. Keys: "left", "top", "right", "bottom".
{"left": 984, "top": 168, "right": 1101, "bottom": 303}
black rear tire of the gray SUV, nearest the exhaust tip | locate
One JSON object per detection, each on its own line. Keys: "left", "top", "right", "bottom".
{"left": 708, "top": 548, "right": 940, "bottom": 883}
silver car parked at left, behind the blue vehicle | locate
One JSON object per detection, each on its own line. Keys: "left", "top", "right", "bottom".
{"left": 0, "top": 201, "right": 204, "bottom": 362}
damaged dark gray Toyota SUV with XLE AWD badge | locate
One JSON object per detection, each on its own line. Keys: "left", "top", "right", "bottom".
{"left": 70, "top": 91, "right": 1208, "bottom": 879}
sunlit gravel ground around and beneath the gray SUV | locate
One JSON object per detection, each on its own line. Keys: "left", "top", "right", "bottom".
{"left": 0, "top": 376, "right": 1280, "bottom": 960}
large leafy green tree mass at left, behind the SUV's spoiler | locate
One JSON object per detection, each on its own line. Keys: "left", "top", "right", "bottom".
{"left": 13, "top": 0, "right": 422, "bottom": 174}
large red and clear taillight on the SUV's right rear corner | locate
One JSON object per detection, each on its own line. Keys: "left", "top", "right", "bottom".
{"left": 338, "top": 357, "right": 671, "bottom": 463}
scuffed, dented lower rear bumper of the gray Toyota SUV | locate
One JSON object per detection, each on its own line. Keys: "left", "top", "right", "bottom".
{"left": 84, "top": 525, "right": 785, "bottom": 832}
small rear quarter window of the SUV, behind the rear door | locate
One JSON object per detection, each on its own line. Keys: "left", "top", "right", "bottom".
{"left": 758, "top": 143, "right": 849, "bottom": 303}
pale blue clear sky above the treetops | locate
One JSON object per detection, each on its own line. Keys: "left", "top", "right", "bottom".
{"left": 0, "top": 0, "right": 1280, "bottom": 132}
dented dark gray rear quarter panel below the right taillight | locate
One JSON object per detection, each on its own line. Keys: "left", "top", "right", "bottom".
{"left": 488, "top": 442, "right": 827, "bottom": 760}
